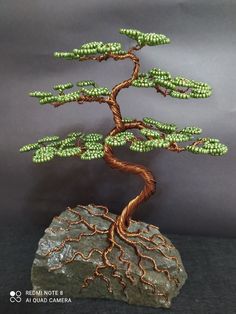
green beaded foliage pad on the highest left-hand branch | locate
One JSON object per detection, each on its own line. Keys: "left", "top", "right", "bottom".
{"left": 54, "top": 41, "right": 126, "bottom": 60}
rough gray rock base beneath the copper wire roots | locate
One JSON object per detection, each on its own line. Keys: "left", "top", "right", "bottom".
{"left": 31, "top": 205, "right": 187, "bottom": 308}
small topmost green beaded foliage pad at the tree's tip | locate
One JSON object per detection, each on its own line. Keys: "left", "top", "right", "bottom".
{"left": 120, "top": 28, "right": 170, "bottom": 46}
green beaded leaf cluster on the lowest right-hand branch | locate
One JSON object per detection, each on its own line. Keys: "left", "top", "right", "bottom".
{"left": 105, "top": 117, "right": 228, "bottom": 156}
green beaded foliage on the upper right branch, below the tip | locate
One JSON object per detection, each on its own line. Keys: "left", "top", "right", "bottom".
{"left": 132, "top": 68, "right": 212, "bottom": 99}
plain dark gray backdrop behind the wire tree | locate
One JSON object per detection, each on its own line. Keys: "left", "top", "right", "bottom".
{"left": 0, "top": 0, "right": 236, "bottom": 237}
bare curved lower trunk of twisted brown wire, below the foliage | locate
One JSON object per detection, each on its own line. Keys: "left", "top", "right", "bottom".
{"left": 104, "top": 145, "right": 156, "bottom": 232}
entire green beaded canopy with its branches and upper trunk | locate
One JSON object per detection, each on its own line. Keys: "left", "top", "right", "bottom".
{"left": 20, "top": 29, "right": 227, "bottom": 163}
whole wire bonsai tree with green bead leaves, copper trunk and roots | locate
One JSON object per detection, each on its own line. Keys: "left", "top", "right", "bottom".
{"left": 20, "top": 29, "right": 227, "bottom": 297}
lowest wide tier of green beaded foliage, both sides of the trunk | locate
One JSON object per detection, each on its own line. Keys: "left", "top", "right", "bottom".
{"left": 20, "top": 117, "right": 228, "bottom": 163}
